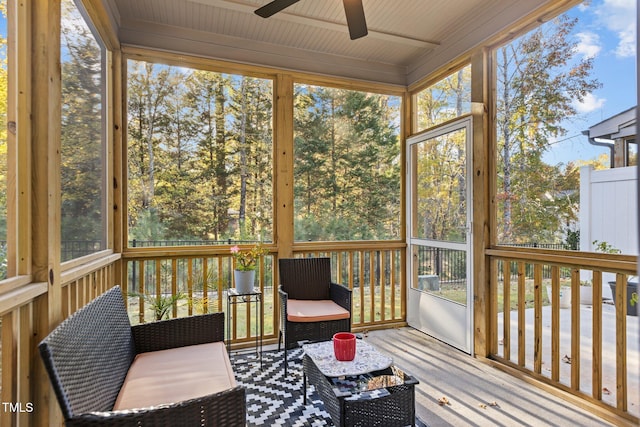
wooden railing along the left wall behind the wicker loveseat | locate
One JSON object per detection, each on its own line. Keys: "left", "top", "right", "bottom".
{"left": 0, "top": 251, "right": 120, "bottom": 426}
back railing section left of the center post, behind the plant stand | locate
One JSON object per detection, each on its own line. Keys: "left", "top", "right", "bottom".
{"left": 123, "top": 247, "right": 277, "bottom": 345}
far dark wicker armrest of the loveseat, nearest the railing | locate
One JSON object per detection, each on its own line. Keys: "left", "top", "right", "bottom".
{"left": 131, "top": 313, "right": 224, "bottom": 353}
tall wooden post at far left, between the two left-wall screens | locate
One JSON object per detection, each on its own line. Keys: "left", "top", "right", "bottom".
{"left": 31, "top": 0, "right": 62, "bottom": 425}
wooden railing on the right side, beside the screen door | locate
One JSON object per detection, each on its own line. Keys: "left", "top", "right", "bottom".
{"left": 488, "top": 249, "right": 640, "bottom": 423}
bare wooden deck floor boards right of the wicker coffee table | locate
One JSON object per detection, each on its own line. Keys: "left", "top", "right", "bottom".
{"left": 364, "top": 327, "right": 624, "bottom": 427}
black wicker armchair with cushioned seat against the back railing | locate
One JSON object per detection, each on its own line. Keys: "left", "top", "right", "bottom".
{"left": 278, "top": 258, "right": 351, "bottom": 375}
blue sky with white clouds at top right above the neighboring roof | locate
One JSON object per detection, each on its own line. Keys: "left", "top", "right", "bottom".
{"left": 545, "top": 0, "right": 637, "bottom": 163}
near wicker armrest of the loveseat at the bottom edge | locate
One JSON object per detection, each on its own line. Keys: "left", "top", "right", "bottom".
{"left": 65, "top": 386, "right": 246, "bottom": 427}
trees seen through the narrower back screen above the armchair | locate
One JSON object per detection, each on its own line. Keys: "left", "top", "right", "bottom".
{"left": 294, "top": 85, "right": 401, "bottom": 241}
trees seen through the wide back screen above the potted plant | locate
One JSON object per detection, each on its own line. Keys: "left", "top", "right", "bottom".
{"left": 127, "top": 61, "right": 273, "bottom": 244}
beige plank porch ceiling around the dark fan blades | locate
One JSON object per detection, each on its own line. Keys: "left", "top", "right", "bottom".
{"left": 106, "top": 0, "right": 560, "bottom": 85}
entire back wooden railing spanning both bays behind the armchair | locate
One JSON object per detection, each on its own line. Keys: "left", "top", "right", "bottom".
{"left": 123, "top": 242, "right": 406, "bottom": 346}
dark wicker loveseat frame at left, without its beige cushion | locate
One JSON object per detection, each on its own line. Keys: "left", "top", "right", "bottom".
{"left": 39, "top": 287, "right": 246, "bottom": 427}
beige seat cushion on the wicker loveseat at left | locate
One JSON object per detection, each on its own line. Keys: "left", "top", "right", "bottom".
{"left": 113, "top": 342, "right": 236, "bottom": 410}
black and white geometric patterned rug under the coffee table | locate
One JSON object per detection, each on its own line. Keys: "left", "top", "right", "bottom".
{"left": 231, "top": 349, "right": 426, "bottom": 427}
